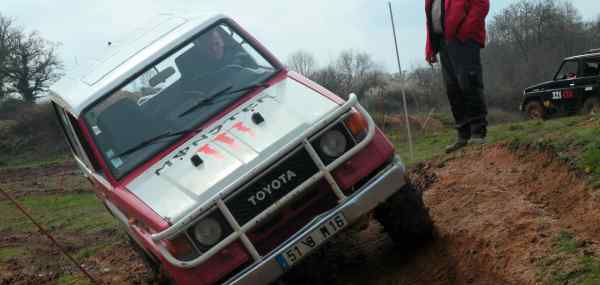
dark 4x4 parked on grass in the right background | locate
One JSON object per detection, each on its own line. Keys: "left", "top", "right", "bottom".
{"left": 520, "top": 49, "right": 600, "bottom": 119}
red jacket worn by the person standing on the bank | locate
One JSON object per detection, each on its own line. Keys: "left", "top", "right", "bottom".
{"left": 425, "top": 0, "right": 490, "bottom": 60}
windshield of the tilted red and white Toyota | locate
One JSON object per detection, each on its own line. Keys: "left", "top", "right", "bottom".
{"left": 84, "top": 24, "right": 276, "bottom": 179}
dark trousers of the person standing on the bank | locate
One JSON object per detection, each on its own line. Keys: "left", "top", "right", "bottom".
{"left": 440, "top": 40, "right": 488, "bottom": 139}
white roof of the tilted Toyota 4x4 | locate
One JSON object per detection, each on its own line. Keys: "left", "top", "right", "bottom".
{"left": 50, "top": 14, "right": 228, "bottom": 117}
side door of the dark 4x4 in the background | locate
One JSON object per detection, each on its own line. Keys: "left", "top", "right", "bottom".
{"left": 548, "top": 59, "right": 580, "bottom": 112}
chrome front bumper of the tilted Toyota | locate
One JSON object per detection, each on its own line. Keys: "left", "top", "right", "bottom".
{"left": 226, "top": 157, "right": 406, "bottom": 285}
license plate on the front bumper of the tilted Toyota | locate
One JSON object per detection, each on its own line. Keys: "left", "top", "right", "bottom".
{"left": 276, "top": 213, "right": 347, "bottom": 269}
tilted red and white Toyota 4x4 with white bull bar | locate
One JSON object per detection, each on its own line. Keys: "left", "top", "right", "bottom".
{"left": 51, "top": 15, "right": 432, "bottom": 285}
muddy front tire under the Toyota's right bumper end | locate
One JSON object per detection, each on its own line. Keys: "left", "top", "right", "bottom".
{"left": 374, "top": 183, "right": 433, "bottom": 247}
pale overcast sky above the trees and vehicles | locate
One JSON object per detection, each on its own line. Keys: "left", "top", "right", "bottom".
{"left": 0, "top": 0, "right": 600, "bottom": 72}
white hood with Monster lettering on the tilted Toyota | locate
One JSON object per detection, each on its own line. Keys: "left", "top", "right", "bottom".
{"left": 127, "top": 79, "right": 339, "bottom": 222}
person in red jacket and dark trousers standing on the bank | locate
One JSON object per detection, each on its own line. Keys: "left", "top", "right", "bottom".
{"left": 425, "top": 0, "right": 490, "bottom": 152}
